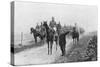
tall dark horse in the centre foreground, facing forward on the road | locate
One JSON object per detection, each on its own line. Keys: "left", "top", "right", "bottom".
{"left": 43, "top": 21, "right": 54, "bottom": 55}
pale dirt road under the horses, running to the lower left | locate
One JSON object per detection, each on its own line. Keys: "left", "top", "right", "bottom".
{"left": 14, "top": 39, "right": 72, "bottom": 65}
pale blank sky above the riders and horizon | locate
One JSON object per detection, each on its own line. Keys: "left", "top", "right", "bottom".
{"left": 14, "top": 1, "right": 98, "bottom": 34}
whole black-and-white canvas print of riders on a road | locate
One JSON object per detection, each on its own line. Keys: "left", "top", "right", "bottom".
{"left": 10, "top": 1, "right": 98, "bottom": 66}
